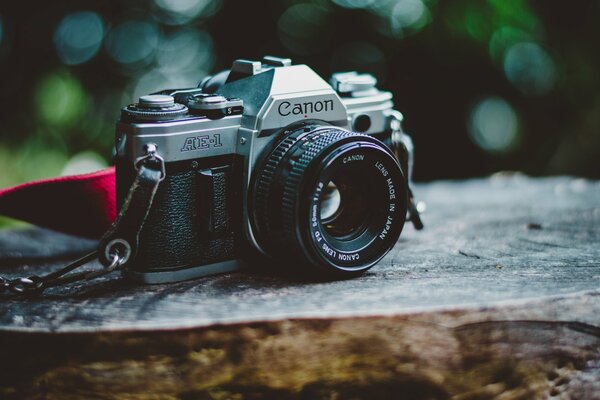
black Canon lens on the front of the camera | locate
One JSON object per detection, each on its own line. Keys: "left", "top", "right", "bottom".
{"left": 249, "top": 124, "right": 408, "bottom": 275}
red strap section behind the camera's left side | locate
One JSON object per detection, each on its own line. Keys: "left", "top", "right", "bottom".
{"left": 0, "top": 167, "right": 116, "bottom": 238}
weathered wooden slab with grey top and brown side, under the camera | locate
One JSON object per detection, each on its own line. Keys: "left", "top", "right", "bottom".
{"left": 0, "top": 175, "right": 600, "bottom": 399}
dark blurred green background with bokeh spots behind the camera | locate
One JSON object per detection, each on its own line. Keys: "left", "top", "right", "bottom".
{"left": 0, "top": 0, "right": 600, "bottom": 191}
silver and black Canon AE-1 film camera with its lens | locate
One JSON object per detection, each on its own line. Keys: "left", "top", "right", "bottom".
{"left": 115, "top": 56, "right": 420, "bottom": 283}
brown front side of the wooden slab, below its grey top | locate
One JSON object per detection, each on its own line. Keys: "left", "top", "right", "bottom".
{"left": 0, "top": 300, "right": 600, "bottom": 399}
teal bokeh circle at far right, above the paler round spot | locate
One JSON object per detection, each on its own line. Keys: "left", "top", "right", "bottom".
{"left": 504, "top": 42, "right": 556, "bottom": 96}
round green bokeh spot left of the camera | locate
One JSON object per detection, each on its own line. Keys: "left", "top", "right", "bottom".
{"left": 35, "top": 72, "right": 87, "bottom": 127}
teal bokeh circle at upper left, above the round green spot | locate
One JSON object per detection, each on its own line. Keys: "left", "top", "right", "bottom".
{"left": 54, "top": 11, "right": 104, "bottom": 65}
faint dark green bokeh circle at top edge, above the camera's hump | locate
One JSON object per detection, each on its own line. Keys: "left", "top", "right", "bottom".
{"left": 277, "top": 3, "right": 330, "bottom": 55}
